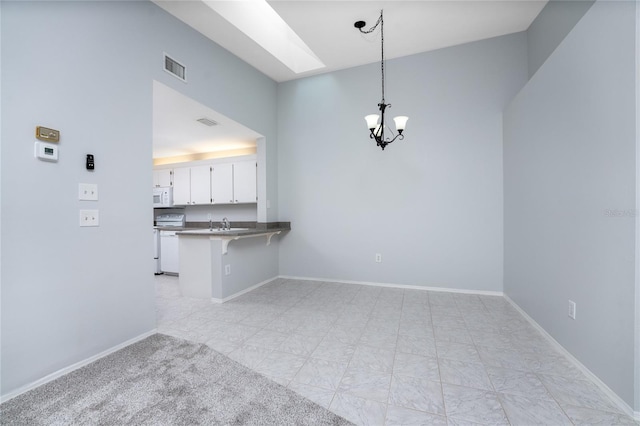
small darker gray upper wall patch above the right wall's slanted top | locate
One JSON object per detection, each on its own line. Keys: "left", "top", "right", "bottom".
{"left": 527, "top": 0, "right": 594, "bottom": 77}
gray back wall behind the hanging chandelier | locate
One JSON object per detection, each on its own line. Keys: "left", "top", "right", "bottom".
{"left": 278, "top": 33, "right": 527, "bottom": 292}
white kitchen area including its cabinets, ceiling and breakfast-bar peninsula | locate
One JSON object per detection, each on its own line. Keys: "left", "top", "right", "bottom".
{"left": 152, "top": 81, "right": 290, "bottom": 303}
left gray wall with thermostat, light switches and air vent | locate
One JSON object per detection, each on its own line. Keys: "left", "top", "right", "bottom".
{"left": 0, "top": 1, "right": 277, "bottom": 395}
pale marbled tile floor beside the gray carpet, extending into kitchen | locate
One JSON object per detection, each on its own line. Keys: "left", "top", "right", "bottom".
{"left": 156, "top": 276, "right": 637, "bottom": 425}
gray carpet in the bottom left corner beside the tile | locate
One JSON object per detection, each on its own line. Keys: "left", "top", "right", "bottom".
{"left": 0, "top": 334, "right": 350, "bottom": 425}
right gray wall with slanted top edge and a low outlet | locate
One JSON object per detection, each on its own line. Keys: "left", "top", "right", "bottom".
{"left": 504, "top": 2, "right": 639, "bottom": 409}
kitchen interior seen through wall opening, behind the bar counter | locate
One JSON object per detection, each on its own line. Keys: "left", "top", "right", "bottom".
{"left": 150, "top": 81, "right": 265, "bottom": 275}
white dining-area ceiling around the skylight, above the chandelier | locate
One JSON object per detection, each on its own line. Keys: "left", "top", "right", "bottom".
{"left": 154, "top": 0, "right": 547, "bottom": 82}
